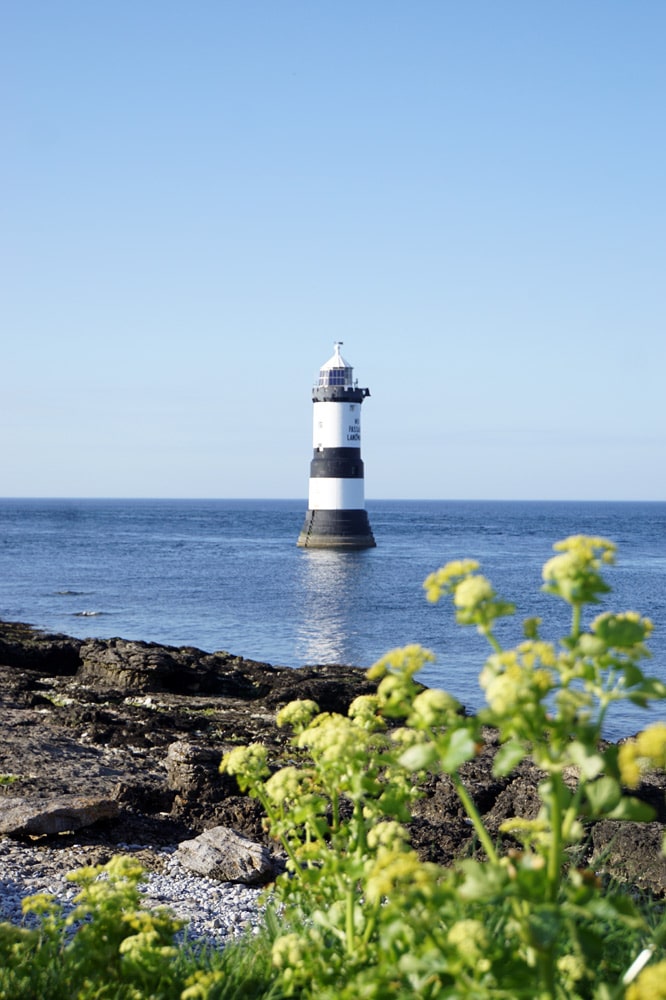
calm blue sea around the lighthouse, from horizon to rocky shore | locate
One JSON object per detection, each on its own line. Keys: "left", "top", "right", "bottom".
{"left": 0, "top": 499, "right": 666, "bottom": 740}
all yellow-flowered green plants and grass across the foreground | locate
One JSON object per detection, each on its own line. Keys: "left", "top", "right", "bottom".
{"left": 0, "top": 536, "right": 666, "bottom": 1000}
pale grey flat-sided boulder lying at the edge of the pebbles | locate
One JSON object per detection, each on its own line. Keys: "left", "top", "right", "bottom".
{"left": 177, "top": 826, "right": 276, "bottom": 885}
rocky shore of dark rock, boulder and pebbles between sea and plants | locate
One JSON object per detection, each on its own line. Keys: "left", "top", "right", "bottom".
{"left": 0, "top": 622, "right": 666, "bottom": 934}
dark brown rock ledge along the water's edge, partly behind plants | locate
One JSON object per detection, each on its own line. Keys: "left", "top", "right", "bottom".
{"left": 0, "top": 622, "right": 666, "bottom": 895}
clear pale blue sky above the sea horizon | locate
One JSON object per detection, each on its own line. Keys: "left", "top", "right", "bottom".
{"left": 0, "top": 0, "right": 666, "bottom": 500}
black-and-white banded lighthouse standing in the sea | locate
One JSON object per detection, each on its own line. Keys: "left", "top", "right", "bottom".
{"left": 296, "top": 341, "right": 376, "bottom": 549}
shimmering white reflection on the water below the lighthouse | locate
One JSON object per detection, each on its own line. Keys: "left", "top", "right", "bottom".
{"left": 296, "top": 549, "right": 366, "bottom": 664}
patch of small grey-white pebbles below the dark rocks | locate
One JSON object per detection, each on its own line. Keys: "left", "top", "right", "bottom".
{"left": 0, "top": 837, "right": 263, "bottom": 947}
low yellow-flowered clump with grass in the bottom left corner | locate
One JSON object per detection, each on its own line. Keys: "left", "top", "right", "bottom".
{"left": 0, "top": 857, "right": 279, "bottom": 1000}
